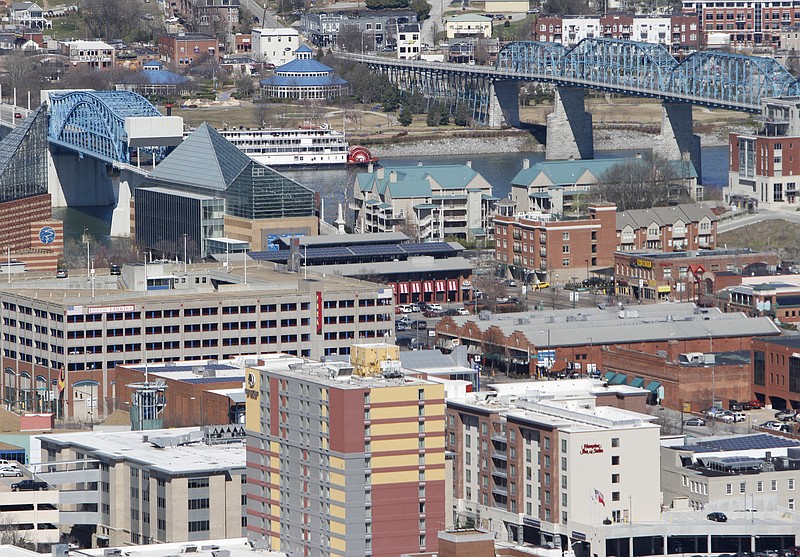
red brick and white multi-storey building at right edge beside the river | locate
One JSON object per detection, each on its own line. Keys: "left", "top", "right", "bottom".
{"left": 723, "top": 96, "right": 800, "bottom": 207}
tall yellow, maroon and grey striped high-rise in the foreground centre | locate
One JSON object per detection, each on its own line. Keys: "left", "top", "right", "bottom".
{"left": 246, "top": 357, "right": 445, "bottom": 557}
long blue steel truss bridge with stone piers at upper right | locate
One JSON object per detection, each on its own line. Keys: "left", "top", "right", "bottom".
{"left": 337, "top": 39, "right": 800, "bottom": 168}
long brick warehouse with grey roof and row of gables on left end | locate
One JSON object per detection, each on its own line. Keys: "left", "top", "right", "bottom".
{"left": 436, "top": 303, "right": 781, "bottom": 375}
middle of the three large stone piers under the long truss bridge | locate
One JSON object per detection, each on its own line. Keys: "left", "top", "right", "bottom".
{"left": 545, "top": 87, "right": 594, "bottom": 160}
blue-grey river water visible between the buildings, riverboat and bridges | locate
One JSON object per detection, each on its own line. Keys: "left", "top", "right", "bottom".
{"left": 53, "top": 146, "right": 728, "bottom": 238}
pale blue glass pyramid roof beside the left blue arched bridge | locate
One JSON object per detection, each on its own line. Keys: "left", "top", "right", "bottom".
{"left": 150, "top": 122, "right": 252, "bottom": 191}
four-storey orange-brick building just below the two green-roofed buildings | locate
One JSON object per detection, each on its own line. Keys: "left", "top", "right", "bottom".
{"left": 494, "top": 204, "right": 617, "bottom": 282}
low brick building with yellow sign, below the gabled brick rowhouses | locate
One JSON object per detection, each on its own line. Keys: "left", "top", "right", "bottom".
{"left": 614, "top": 249, "right": 778, "bottom": 302}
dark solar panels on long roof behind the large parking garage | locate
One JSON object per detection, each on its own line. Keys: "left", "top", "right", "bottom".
{"left": 250, "top": 242, "right": 458, "bottom": 263}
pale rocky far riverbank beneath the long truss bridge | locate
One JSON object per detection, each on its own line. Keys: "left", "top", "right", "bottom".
{"left": 367, "top": 128, "right": 728, "bottom": 158}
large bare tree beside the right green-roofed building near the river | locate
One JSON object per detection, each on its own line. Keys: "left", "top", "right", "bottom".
{"left": 595, "top": 153, "right": 682, "bottom": 211}
